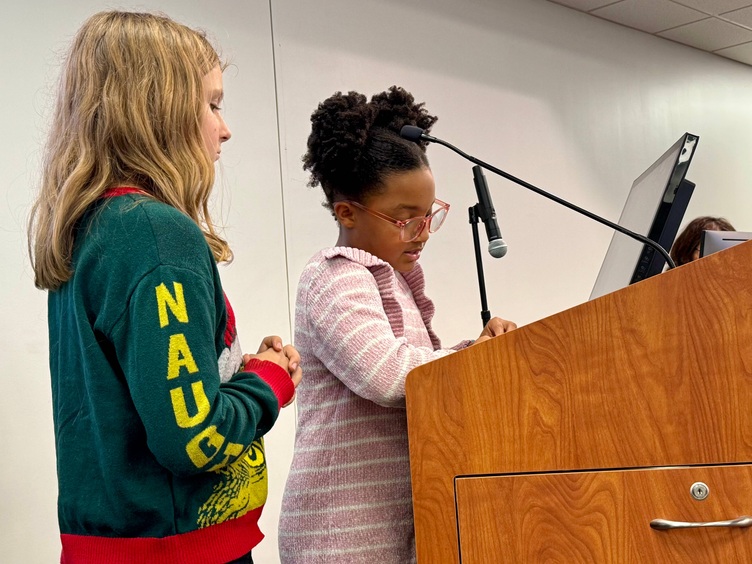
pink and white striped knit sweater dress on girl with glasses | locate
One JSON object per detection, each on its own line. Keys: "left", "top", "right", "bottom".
{"left": 279, "top": 247, "right": 468, "bottom": 564}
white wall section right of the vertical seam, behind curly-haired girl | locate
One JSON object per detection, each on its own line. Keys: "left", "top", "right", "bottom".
{"left": 273, "top": 0, "right": 752, "bottom": 343}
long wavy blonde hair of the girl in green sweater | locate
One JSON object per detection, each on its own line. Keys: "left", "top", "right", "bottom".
{"left": 29, "top": 11, "right": 232, "bottom": 290}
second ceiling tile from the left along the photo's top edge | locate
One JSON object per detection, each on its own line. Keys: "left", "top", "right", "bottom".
{"left": 590, "top": 0, "right": 707, "bottom": 33}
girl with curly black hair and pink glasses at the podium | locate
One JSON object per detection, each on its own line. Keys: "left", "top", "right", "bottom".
{"left": 279, "top": 86, "right": 515, "bottom": 564}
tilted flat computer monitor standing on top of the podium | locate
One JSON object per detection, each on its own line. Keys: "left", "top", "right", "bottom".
{"left": 590, "top": 133, "right": 699, "bottom": 299}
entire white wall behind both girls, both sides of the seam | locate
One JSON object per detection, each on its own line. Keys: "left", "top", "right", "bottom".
{"left": 0, "top": 0, "right": 752, "bottom": 562}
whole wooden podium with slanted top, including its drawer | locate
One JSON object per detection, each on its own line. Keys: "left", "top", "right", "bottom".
{"left": 406, "top": 242, "right": 752, "bottom": 564}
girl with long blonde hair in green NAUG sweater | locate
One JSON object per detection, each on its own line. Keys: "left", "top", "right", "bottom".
{"left": 29, "top": 11, "right": 302, "bottom": 564}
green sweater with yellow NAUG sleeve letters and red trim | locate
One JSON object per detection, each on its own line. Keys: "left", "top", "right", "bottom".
{"left": 48, "top": 188, "right": 294, "bottom": 564}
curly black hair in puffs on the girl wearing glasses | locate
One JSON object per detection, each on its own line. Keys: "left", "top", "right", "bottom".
{"left": 303, "top": 86, "right": 437, "bottom": 211}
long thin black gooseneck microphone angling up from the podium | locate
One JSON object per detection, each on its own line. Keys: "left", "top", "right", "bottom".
{"left": 400, "top": 125, "right": 676, "bottom": 268}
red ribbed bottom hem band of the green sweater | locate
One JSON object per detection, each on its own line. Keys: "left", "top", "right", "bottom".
{"left": 60, "top": 506, "right": 264, "bottom": 564}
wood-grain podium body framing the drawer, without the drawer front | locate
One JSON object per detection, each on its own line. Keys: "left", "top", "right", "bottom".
{"left": 406, "top": 243, "right": 752, "bottom": 564}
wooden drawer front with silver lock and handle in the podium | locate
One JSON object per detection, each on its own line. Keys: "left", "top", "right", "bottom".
{"left": 455, "top": 465, "right": 752, "bottom": 564}
